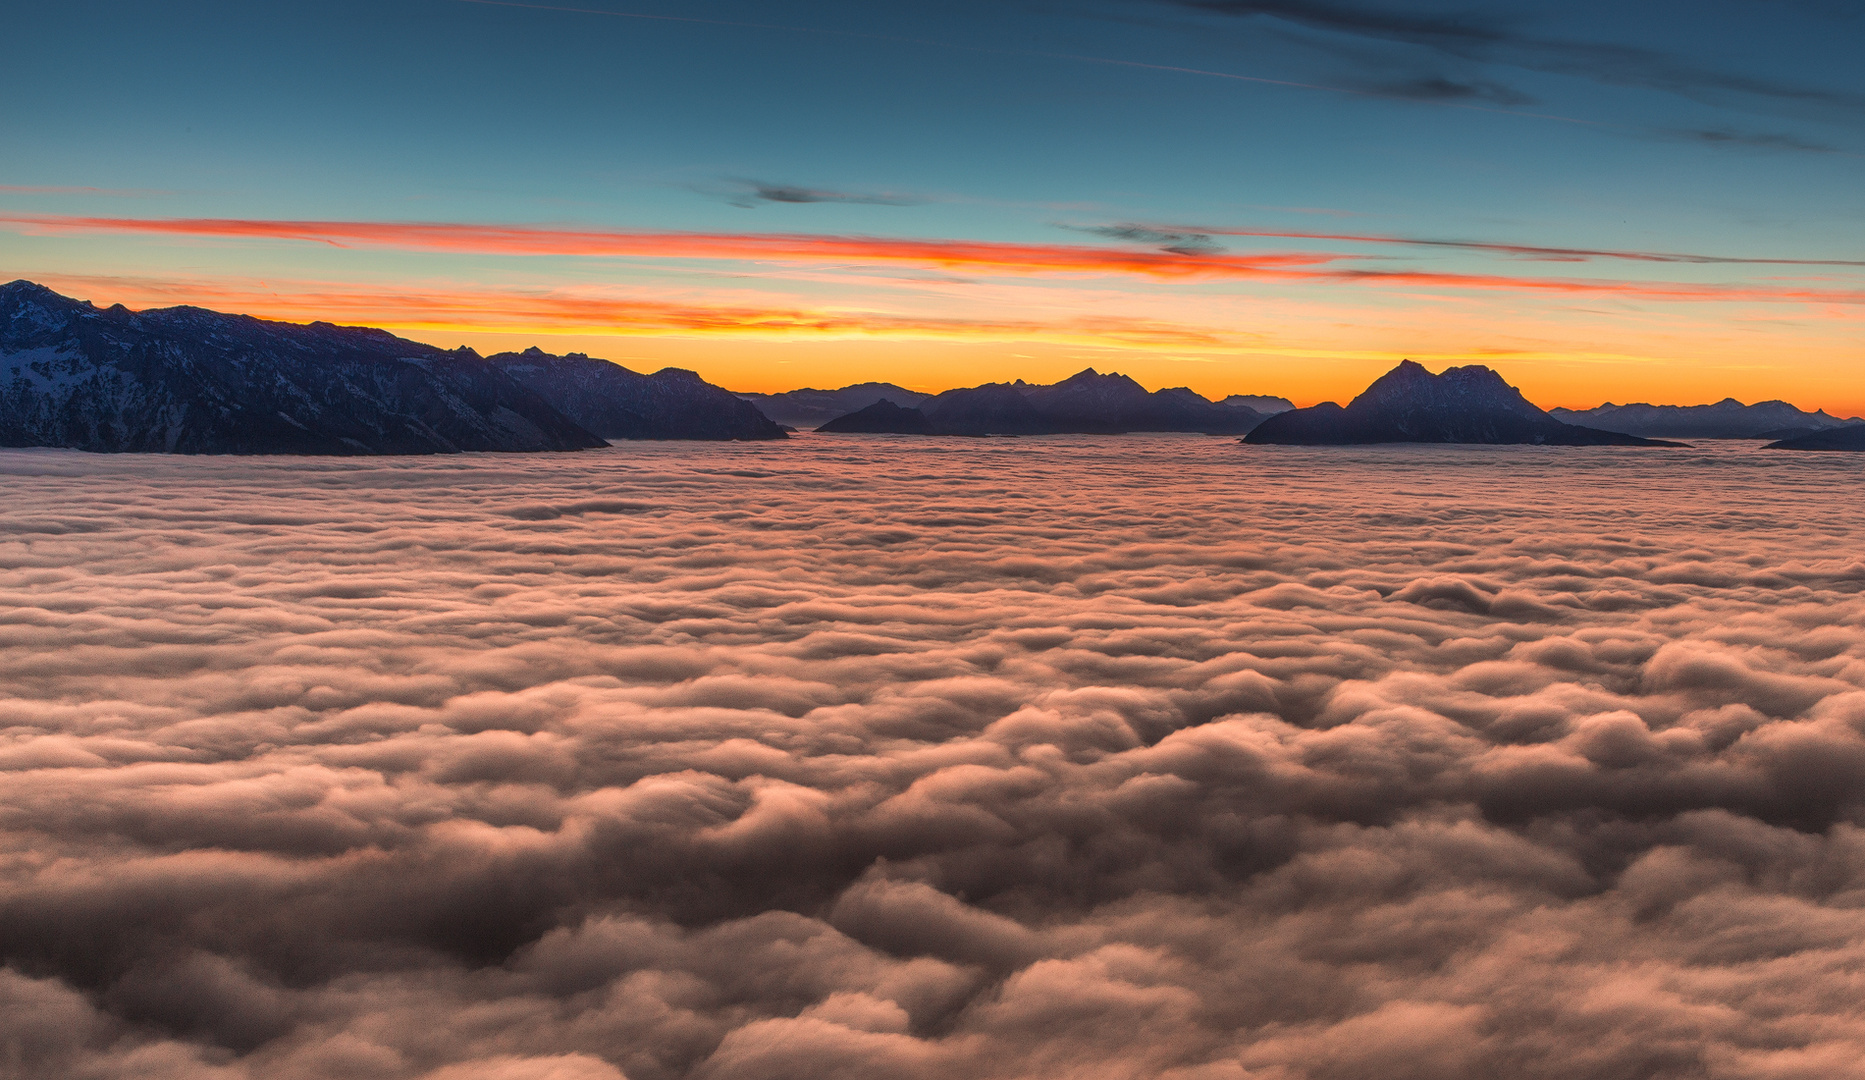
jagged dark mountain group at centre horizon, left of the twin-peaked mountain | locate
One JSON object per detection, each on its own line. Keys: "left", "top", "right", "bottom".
{"left": 817, "top": 367, "right": 1263, "bottom": 435}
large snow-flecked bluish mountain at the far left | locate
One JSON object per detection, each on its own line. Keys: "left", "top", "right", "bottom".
{"left": 0, "top": 282, "right": 602, "bottom": 455}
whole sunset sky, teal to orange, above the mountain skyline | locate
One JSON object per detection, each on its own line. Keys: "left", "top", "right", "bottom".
{"left": 0, "top": 0, "right": 1865, "bottom": 414}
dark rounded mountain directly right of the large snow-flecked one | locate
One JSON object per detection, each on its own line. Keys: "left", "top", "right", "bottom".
{"left": 487, "top": 347, "right": 785, "bottom": 440}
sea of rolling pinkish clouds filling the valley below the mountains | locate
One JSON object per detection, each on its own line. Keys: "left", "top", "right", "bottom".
{"left": 0, "top": 436, "right": 1865, "bottom": 1080}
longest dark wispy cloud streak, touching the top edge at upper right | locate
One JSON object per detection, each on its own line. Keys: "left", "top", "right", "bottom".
{"left": 1162, "top": 0, "right": 1865, "bottom": 112}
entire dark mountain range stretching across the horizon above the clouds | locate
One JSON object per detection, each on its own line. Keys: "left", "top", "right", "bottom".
{"left": 0, "top": 282, "right": 1865, "bottom": 455}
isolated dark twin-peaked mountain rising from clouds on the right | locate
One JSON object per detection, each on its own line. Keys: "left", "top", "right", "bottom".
{"left": 1244, "top": 360, "right": 1677, "bottom": 446}
